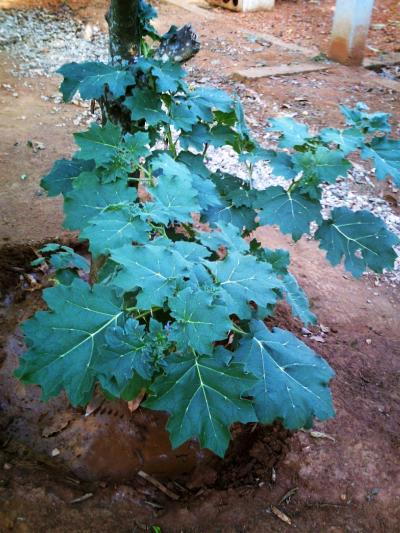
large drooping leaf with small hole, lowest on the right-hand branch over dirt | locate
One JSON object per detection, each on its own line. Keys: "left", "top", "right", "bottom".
{"left": 315, "top": 207, "right": 400, "bottom": 277}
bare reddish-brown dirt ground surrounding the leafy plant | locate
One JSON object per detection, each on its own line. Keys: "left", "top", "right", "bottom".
{"left": 0, "top": 0, "right": 400, "bottom": 533}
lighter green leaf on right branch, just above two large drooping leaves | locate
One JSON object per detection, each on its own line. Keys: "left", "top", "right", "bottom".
{"left": 293, "top": 146, "right": 351, "bottom": 183}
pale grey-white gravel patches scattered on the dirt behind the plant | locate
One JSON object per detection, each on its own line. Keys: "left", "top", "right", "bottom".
{"left": 0, "top": 8, "right": 400, "bottom": 286}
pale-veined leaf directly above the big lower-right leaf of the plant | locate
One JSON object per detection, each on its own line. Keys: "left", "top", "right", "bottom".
{"left": 207, "top": 252, "right": 282, "bottom": 319}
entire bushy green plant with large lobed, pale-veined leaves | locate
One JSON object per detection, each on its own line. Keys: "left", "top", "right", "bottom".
{"left": 16, "top": 5, "right": 400, "bottom": 456}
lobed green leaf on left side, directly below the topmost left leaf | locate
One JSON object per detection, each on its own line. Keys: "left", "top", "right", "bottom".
{"left": 74, "top": 122, "right": 122, "bottom": 165}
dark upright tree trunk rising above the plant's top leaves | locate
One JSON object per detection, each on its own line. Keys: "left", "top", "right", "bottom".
{"left": 106, "top": 0, "right": 141, "bottom": 65}
